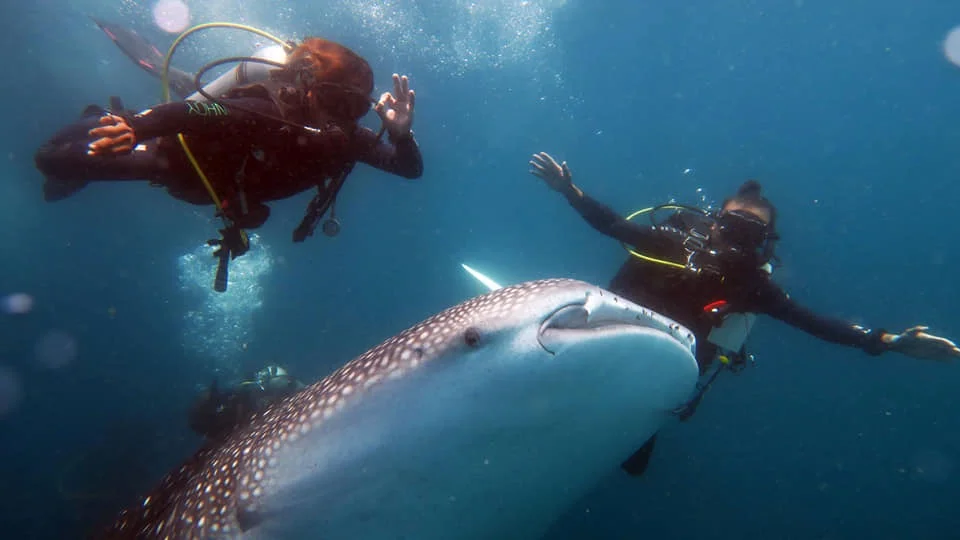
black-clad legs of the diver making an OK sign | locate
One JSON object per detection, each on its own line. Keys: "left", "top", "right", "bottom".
{"left": 34, "top": 115, "right": 166, "bottom": 201}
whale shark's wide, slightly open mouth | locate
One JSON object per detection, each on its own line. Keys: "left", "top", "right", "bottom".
{"left": 537, "top": 296, "right": 692, "bottom": 354}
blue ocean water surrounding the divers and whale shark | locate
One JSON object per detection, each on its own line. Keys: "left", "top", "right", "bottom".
{"left": 0, "top": 0, "right": 960, "bottom": 539}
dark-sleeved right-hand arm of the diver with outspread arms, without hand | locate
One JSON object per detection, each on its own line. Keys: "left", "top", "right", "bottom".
{"left": 760, "top": 281, "right": 893, "bottom": 356}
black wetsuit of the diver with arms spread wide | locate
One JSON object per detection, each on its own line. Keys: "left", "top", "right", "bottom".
{"left": 566, "top": 190, "right": 886, "bottom": 476}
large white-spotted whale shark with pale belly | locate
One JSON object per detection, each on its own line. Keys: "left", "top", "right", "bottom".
{"left": 103, "top": 279, "right": 698, "bottom": 540}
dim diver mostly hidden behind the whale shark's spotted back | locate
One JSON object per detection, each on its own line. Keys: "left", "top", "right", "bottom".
{"left": 189, "top": 365, "right": 305, "bottom": 442}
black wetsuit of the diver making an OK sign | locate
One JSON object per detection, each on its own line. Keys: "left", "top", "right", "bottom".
{"left": 35, "top": 90, "right": 423, "bottom": 227}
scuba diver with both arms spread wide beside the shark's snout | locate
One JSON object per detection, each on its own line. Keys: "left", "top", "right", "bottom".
{"left": 530, "top": 152, "right": 960, "bottom": 476}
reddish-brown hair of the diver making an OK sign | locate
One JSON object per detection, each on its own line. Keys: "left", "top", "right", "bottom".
{"left": 288, "top": 37, "right": 373, "bottom": 96}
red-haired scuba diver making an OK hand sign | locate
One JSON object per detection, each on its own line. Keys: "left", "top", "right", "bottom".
{"left": 34, "top": 21, "right": 423, "bottom": 292}
